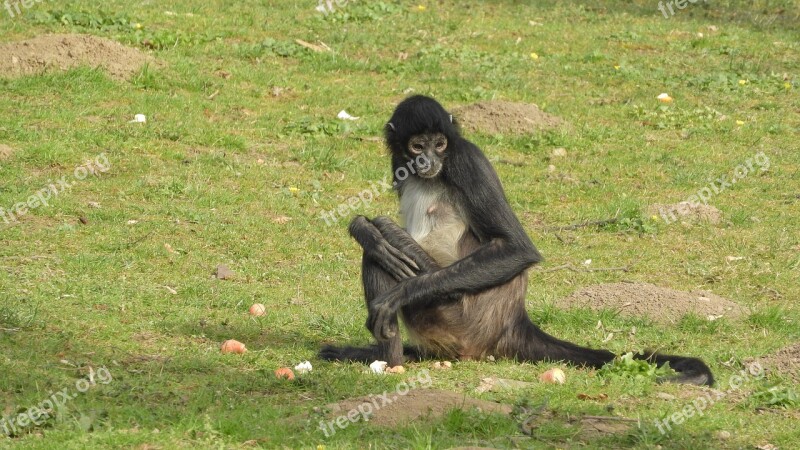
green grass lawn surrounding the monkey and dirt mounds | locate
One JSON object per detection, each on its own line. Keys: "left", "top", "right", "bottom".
{"left": 0, "top": 0, "right": 800, "bottom": 449}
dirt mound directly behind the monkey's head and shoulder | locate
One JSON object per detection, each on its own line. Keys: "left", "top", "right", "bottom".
{"left": 453, "top": 101, "right": 563, "bottom": 134}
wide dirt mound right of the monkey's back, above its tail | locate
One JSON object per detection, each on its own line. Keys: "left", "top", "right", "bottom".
{"left": 559, "top": 283, "right": 747, "bottom": 323}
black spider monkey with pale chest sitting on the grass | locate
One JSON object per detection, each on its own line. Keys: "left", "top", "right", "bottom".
{"left": 320, "top": 95, "right": 714, "bottom": 385}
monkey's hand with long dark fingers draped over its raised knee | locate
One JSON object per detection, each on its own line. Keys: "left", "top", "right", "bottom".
{"left": 349, "top": 216, "right": 419, "bottom": 281}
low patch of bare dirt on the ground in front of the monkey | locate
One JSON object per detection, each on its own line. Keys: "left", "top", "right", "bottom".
{"left": 318, "top": 389, "right": 511, "bottom": 427}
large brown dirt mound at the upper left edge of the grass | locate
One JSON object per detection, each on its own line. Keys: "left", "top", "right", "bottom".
{"left": 0, "top": 34, "right": 153, "bottom": 79}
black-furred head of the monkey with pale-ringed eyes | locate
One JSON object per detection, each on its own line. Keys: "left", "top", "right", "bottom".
{"left": 386, "top": 95, "right": 460, "bottom": 178}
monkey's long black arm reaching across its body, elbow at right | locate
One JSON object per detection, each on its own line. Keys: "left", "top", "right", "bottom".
{"left": 367, "top": 141, "right": 542, "bottom": 338}
